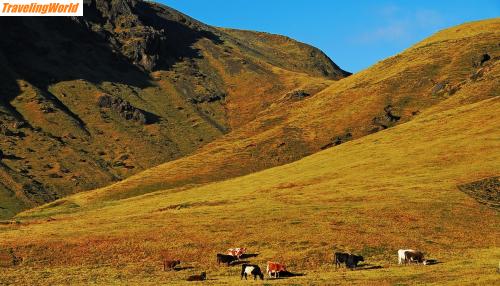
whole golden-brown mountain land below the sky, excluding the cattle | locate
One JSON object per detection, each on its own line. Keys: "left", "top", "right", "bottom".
{"left": 0, "top": 1, "right": 500, "bottom": 285}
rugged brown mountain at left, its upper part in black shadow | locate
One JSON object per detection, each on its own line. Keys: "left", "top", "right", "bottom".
{"left": 0, "top": 0, "right": 349, "bottom": 217}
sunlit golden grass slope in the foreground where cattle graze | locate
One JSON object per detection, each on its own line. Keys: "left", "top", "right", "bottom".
{"left": 0, "top": 90, "right": 500, "bottom": 285}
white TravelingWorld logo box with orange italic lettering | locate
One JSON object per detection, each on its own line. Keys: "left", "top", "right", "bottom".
{"left": 0, "top": 0, "right": 83, "bottom": 16}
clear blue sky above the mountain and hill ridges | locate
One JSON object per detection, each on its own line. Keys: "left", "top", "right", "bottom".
{"left": 157, "top": 0, "right": 500, "bottom": 72}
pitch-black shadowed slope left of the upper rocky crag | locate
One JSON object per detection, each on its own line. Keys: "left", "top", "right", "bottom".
{"left": 0, "top": 17, "right": 152, "bottom": 92}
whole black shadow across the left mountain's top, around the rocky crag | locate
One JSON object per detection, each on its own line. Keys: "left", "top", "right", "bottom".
{"left": 0, "top": 2, "right": 222, "bottom": 102}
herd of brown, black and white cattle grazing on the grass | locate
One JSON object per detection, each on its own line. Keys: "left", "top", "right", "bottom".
{"left": 163, "top": 247, "right": 428, "bottom": 281}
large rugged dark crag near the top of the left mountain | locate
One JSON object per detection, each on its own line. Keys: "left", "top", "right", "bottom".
{"left": 82, "top": 0, "right": 217, "bottom": 71}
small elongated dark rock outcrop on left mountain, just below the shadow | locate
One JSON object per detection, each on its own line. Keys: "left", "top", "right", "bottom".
{"left": 97, "top": 94, "right": 148, "bottom": 124}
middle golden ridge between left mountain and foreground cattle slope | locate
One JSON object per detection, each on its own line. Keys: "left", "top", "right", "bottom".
{"left": 38, "top": 19, "right": 500, "bottom": 208}
